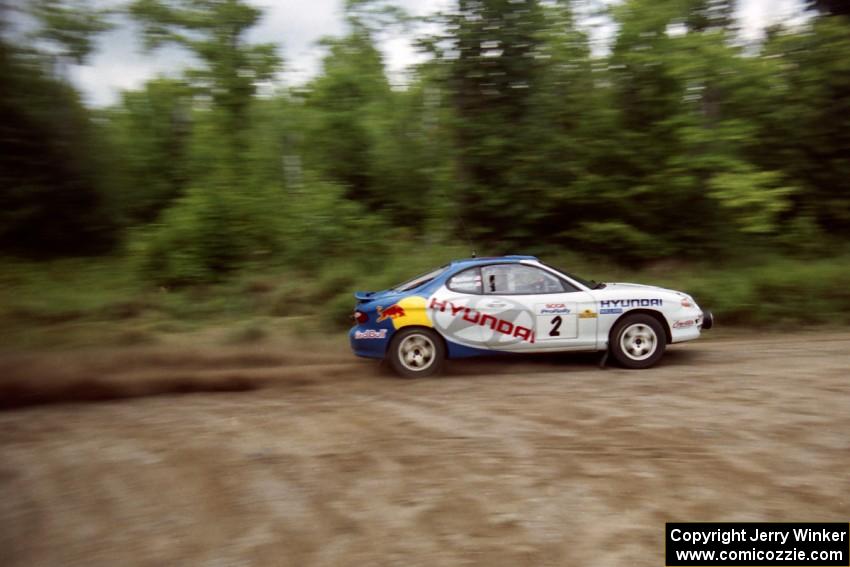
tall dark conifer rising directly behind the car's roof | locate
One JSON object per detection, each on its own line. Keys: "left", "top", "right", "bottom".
{"left": 430, "top": 0, "right": 544, "bottom": 240}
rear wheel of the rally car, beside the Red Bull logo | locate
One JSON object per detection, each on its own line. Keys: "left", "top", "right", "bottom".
{"left": 387, "top": 328, "right": 446, "bottom": 378}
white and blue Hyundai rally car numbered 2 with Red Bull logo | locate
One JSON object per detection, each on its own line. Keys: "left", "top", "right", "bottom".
{"left": 349, "top": 256, "right": 713, "bottom": 377}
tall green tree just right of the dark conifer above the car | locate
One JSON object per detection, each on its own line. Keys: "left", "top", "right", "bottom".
{"left": 516, "top": 2, "right": 604, "bottom": 244}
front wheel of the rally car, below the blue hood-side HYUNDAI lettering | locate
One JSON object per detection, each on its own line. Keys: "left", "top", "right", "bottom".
{"left": 608, "top": 314, "right": 667, "bottom": 368}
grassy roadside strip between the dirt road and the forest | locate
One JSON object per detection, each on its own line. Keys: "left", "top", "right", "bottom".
{"left": 0, "top": 251, "right": 850, "bottom": 350}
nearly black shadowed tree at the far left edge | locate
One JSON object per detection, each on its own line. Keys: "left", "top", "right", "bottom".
{"left": 0, "top": 37, "right": 115, "bottom": 257}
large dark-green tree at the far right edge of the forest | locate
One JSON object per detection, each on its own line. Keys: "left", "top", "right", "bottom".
{"left": 754, "top": 17, "right": 850, "bottom": 239}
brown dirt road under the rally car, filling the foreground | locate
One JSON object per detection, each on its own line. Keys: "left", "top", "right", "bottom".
{"left": 0, "top": 332, "right": 850, "bottom": 567}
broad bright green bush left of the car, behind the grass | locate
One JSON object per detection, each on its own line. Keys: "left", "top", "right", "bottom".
{"left": 131, "top": 176, "right": 400, "bottom": 286}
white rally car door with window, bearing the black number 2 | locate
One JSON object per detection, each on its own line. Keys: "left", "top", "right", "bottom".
{"left": 479, "top": 263, "right": 597, "bottom": 351}
